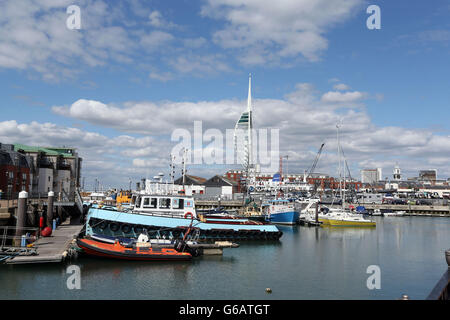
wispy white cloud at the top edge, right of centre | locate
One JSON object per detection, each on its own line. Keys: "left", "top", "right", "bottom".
{"left": 201, "top": 0, "right": 363, "bottom": 64}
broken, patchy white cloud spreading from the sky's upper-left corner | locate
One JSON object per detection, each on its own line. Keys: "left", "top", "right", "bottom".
{"left": 0, "top": 0, "right": 239, "bottom": 82}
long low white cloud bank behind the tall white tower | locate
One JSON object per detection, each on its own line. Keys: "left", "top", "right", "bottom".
{"left": 47, "top": 83, "right": 450, "bottom": 180}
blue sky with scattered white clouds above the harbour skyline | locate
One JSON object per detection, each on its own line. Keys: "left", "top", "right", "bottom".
{"left": 0, "top": 0, "right": 450, "bottom": 187}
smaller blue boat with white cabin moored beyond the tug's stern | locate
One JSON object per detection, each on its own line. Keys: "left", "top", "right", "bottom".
{"left": 264, "top": 199, "right": 300, "bottom": 225}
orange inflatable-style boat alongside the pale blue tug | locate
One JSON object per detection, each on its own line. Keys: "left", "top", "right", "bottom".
{"left": 77, "top": 238, "right": 192, "bottom": 261}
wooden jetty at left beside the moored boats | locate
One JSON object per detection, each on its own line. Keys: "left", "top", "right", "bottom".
{"left": 5, "top": 222, "right": 83, "bottom": 264}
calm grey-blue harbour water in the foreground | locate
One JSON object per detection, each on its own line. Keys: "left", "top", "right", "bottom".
{"left": 0, "top": 217, "right": 450, "bottom": 300}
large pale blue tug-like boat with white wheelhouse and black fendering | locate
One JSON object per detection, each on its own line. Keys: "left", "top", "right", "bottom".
{"left": 86, "top": 195, "right": 283, "bottom": 241}
